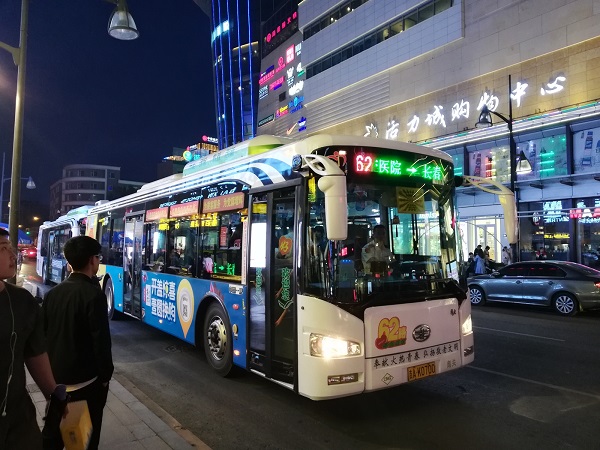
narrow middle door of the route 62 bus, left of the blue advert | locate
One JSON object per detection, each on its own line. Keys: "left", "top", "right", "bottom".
{"left": 123, "top": 213, "right": 144, "bottom": 319}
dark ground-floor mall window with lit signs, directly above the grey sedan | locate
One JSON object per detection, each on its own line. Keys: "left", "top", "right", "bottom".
{"left": 519, "top": 200, "right": 571, "bottom": 261}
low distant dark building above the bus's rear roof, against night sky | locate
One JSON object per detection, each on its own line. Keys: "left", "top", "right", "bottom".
{"left": 49, "top": 164, "right": 145, "bottom": 220}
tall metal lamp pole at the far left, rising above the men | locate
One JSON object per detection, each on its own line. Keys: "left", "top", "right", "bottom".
{"left": 8, "top": 0, "right": 29, "bottom": 283}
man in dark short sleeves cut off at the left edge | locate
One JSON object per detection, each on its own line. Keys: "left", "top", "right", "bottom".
{"left": 0, "top": 228, "right": 66, "bottom": 450}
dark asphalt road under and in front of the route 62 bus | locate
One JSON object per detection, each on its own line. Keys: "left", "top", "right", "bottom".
{"left": 21, "top": 262, "right": 600, "bottom": 450}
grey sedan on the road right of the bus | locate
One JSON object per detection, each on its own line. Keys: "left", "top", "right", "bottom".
{"left": 467, "top": 261, "right": 600, "bottom": 316}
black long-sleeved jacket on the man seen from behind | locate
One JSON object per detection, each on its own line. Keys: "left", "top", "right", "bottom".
{"left": 42, "top": 273, "right": 114, "bottom": 384}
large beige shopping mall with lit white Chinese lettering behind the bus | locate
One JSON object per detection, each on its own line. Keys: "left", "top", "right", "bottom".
{"left": 257, "top": 0, "right": 600, "bottom": 265}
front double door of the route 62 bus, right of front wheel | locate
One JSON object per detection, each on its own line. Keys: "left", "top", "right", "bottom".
{"left": 248, "top": 187, "right": 297, "bottom": 384}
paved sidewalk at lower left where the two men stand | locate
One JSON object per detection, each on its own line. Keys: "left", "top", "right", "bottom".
{"left": 26, "top": 371, "right": 210, "bottom": 450}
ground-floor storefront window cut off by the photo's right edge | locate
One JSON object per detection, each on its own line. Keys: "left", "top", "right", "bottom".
{"left": 571, "top": 198, "right": 600, "bottom": 270}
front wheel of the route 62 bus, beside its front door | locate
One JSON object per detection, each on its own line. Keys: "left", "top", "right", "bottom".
{"left": 204, "top": 302, "right": 233, "bottom": 377}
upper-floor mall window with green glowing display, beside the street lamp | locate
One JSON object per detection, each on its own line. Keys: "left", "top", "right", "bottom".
{"left": 517, "top": 134, "right": 568, "bottom": 181}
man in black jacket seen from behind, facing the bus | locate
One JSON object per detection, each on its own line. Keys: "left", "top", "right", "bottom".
{"left": 42, "top": 236, "right": 114, "bottom": 450}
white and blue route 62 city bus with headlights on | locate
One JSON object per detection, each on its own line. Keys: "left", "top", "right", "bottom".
{"left": 87, "top": 135, "right": 474, "bottom": 400}
